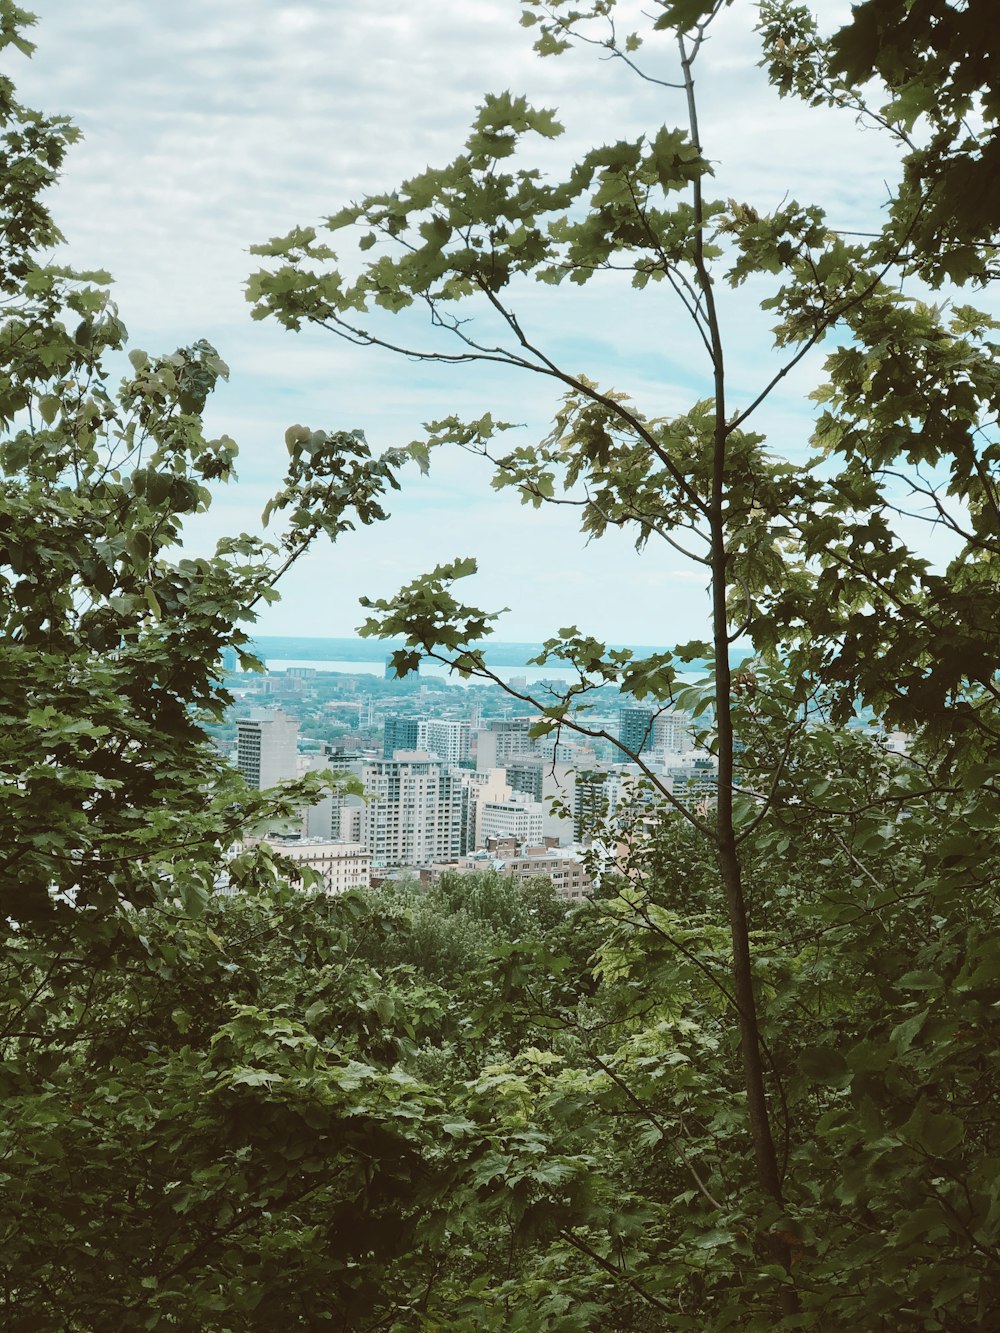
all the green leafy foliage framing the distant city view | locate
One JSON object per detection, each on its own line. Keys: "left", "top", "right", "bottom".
{"left": 0, "top": 0, "right": 1000, "bottom": 1333}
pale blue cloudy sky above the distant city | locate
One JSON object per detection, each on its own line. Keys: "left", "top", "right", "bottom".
{"left": 15, "top": 0, "right": 912, "bottom": 644}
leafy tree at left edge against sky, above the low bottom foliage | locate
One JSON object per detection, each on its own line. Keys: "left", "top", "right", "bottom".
{"left": 0, "top": 4, "right": 416, "bottom": 940}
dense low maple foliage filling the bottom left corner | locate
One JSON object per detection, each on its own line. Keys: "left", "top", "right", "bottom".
{"left": 3, "top": 890, "right": 453, "bottom": 1329}
